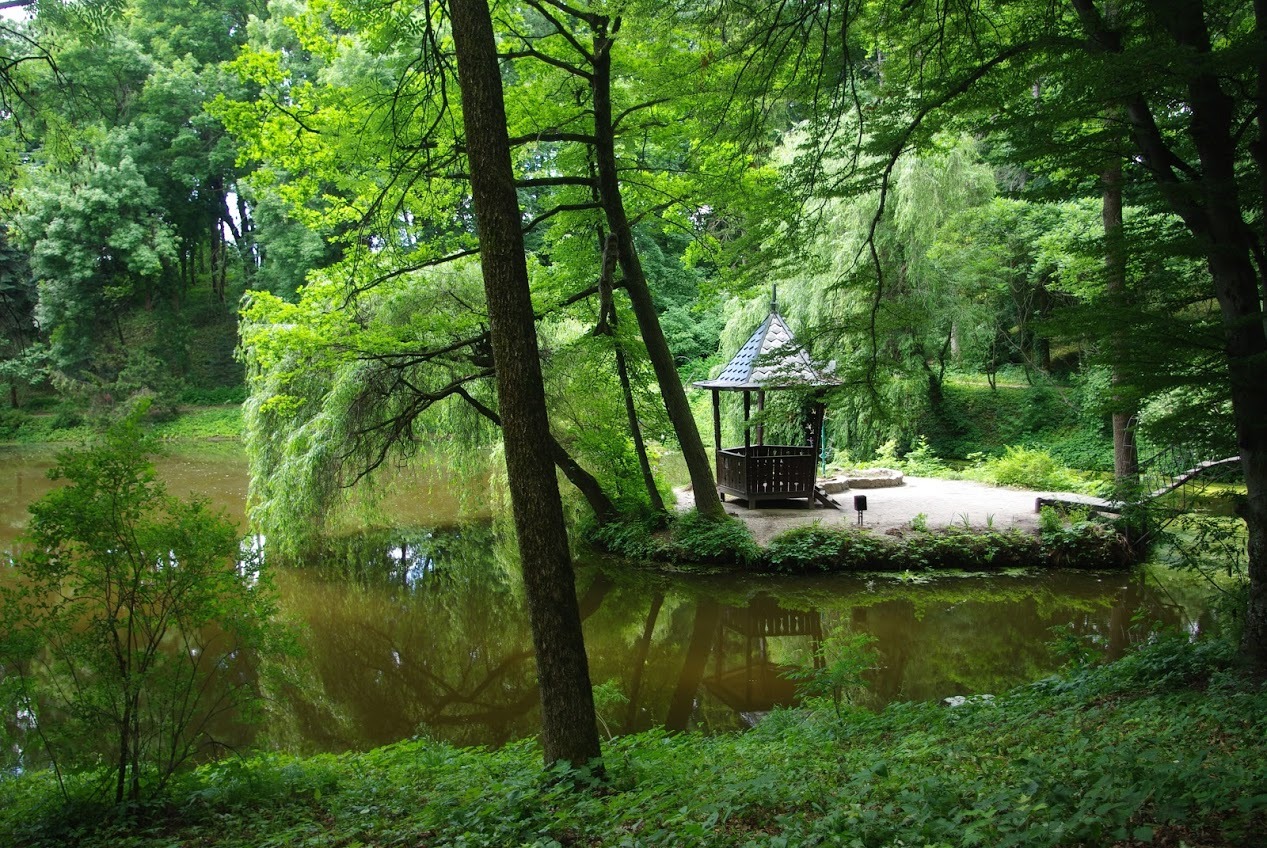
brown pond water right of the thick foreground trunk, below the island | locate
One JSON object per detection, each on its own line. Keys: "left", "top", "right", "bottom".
{"left": 587, "top": 572, "right": 1196, "bottom": 730}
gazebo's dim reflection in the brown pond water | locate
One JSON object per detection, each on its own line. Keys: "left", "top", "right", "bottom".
{"left": 704, "top": 596, "right": 822, "bottom": 715}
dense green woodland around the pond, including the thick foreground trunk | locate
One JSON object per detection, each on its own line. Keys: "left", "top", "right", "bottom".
{"left": 0, "top": 0, "right": 1267, "bottom": 826}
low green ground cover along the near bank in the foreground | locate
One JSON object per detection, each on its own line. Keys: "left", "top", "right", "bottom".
{"left": 0, "top": 636, "right": 1267, "bottom": 848}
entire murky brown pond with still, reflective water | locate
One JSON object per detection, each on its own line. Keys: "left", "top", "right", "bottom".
{"left": 0, "top": 445, "right": 1202, "bottom": 752}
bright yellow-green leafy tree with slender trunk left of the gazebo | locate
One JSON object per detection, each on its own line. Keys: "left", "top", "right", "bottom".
{"left": 217, "top": 3, "right": 750, "bottom": 524}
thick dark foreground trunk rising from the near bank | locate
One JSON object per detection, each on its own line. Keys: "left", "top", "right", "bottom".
{"left": 450, "top": 0, "right": 601, "bottom": 766}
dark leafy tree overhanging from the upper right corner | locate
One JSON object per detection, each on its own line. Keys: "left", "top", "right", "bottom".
{"left": 729, "top": 0, "right": 1267, "bottom": 667}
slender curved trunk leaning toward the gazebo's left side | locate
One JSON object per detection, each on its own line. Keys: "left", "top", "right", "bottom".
{"left": 590, "top": 26, "right": 726, "bottom": 518}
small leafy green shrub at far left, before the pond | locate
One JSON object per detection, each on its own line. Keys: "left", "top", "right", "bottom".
{"left": 0, "top": 408, "right": 284, "bottom": 802}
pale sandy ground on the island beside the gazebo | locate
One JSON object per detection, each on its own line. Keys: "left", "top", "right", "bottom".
{"left": 677, "top": 477, "right": 1104, "bottom": 545}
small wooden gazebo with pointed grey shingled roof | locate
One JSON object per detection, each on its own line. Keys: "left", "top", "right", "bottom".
{"left": 696, "top": 294, "right": 836, "bottom": 508}
